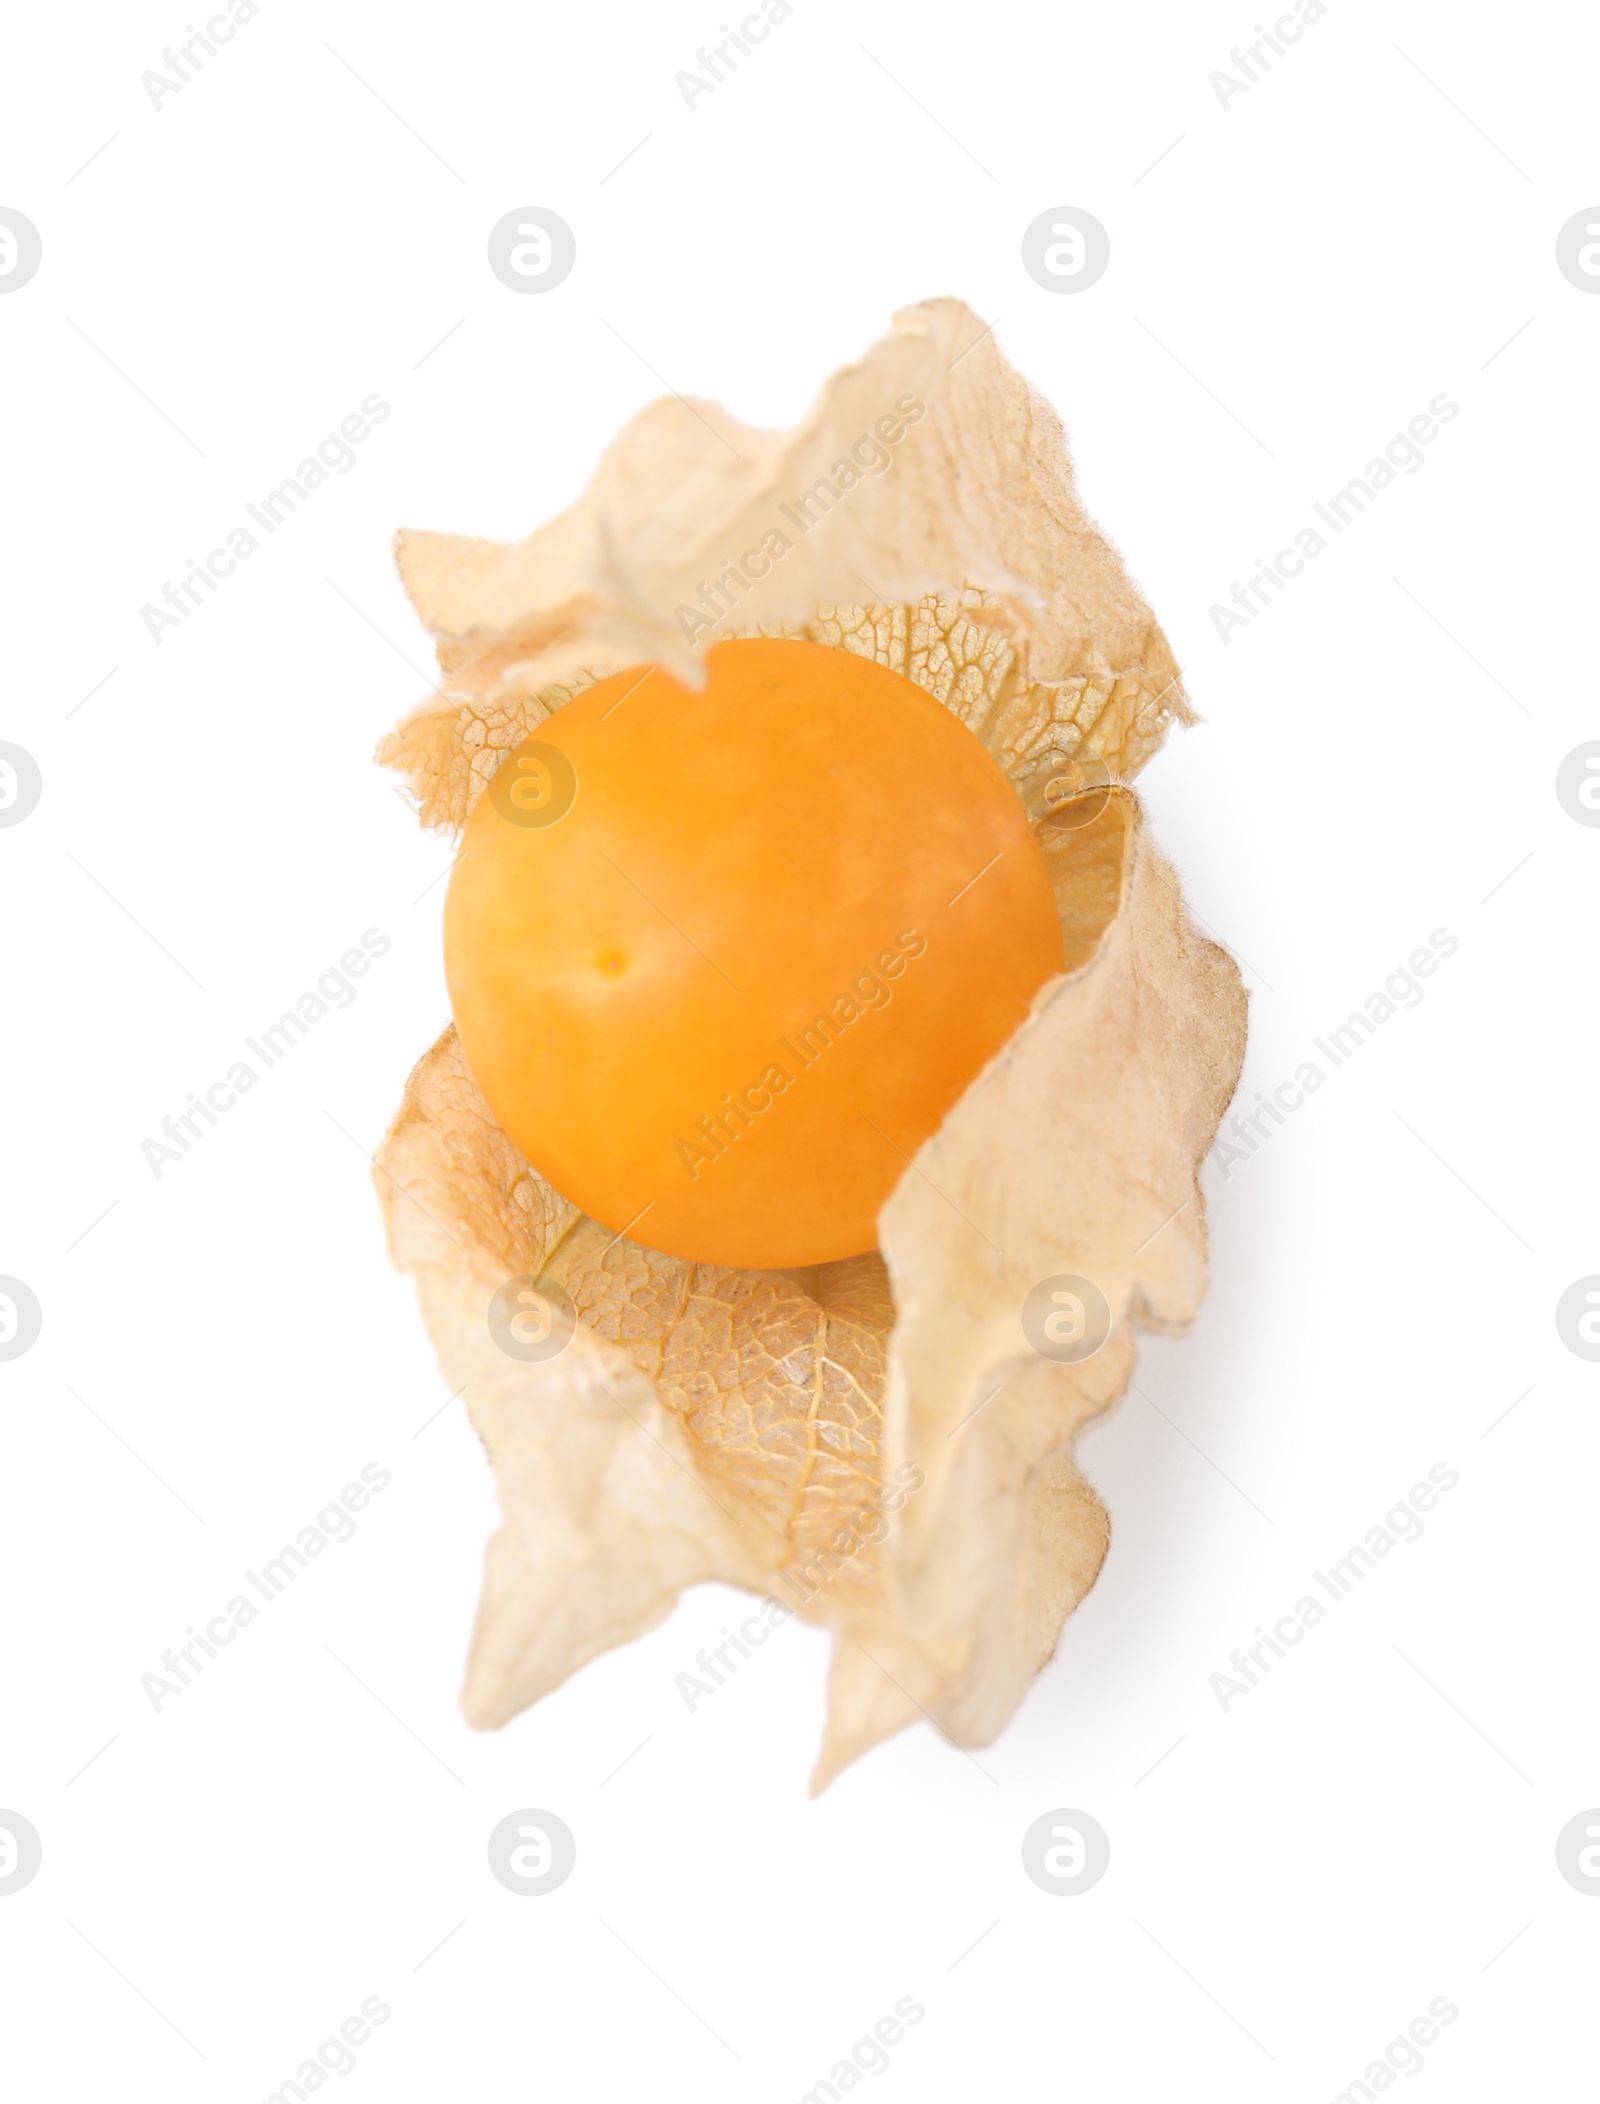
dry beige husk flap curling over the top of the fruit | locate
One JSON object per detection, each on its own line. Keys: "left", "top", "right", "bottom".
{"left": 379, "top": 299, "right": 1187, "bottom": 829}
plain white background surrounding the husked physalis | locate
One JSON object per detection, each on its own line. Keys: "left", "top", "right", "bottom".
{"left": 0, "top": 0, "right": 1600, "bottom": 2104}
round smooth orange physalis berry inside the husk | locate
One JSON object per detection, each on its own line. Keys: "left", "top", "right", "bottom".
{"left": 444, "top": 640, "right": 1063, "bottom": 1269}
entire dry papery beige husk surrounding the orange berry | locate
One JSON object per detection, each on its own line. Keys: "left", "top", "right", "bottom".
{"left": 379, "top": 301, "right": 1244, "bottom": 1786}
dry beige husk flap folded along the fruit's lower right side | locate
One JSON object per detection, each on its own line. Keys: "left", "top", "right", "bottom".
{"left": 819, "top": 791, "right": 1244, "bottom": 1780}
